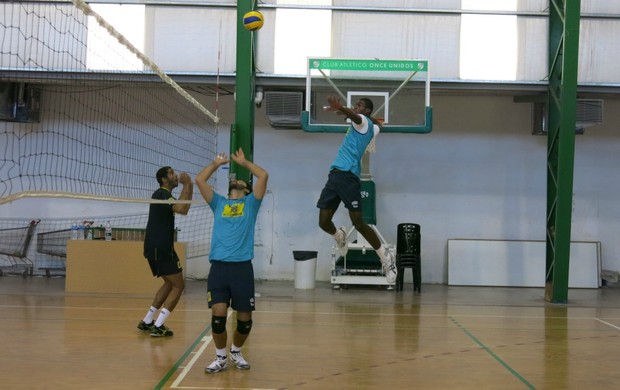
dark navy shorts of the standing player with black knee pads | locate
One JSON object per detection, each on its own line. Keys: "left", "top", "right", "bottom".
{"left": 207, "top": 261, "right": 255, "bottom": 312}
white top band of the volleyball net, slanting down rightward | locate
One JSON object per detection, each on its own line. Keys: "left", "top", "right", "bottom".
{"left": 73, "top": 0, "right": 220, "bottom": 123}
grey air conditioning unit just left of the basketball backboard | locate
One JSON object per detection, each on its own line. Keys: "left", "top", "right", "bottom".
{"left": 265, "top": 91, "right": 304, "bottom": 129}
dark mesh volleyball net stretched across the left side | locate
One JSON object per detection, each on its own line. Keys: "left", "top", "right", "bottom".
{"left": 0, "top": 0, "right": 219, "bottom": 272}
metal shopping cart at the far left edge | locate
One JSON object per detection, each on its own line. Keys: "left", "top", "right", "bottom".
{"left": 0, "top": 219, "right": 41, "bottom": 278}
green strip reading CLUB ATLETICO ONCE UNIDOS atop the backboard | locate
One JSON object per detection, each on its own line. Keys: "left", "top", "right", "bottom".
{"left": 308, "top": 58, "right": 428, "bottom": 72}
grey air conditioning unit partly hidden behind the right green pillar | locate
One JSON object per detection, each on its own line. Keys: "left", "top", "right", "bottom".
{"left": 532, "top": 99, "right": 603, "bottom": 135}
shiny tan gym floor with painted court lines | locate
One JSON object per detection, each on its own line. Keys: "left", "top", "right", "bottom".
{"left": 0, "top": 276, "right": 620, "bottom": 390}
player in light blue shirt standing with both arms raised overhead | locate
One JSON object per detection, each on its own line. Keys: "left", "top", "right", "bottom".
{"left": 196, "top": 148, "right": 269, "bottom": 374}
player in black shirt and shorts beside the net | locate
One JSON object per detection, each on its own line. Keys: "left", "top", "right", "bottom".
{"left": 138, "top": 167, "right": 194, "bottom": 337}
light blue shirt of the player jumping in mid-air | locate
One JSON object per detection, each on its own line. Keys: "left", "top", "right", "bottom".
{"left": 329, "top": 115, "right": 375, "bottom": 177}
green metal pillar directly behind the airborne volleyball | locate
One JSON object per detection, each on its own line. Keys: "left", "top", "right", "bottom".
{"left": 230, "top": 0, "right": 256, "bottom": 182}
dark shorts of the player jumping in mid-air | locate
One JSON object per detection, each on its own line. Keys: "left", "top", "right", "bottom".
{"left": 316, "top": 169, "right": 362, "bottom": 212}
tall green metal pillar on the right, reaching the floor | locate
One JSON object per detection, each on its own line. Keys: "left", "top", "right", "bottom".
{"left": 545, "top": 0, "right": 581, "bottom": 303}
